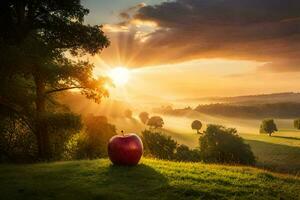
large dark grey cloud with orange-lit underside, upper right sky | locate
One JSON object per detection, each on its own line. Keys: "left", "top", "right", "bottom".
{"left": 100, "top": 0, "right": 300, "bottom": 71}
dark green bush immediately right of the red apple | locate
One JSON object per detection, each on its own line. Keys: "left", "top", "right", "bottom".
{"left": 142, "top": 130, "right": 177, "bottom": 160}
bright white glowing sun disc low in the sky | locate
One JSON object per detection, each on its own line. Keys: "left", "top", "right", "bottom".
{"left": 108, "top": 66, "right": 129, "bottom": 85}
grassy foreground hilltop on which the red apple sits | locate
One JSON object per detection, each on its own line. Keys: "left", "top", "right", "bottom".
{"left": 0, "top": 159, "right": 300, "bottom": 200}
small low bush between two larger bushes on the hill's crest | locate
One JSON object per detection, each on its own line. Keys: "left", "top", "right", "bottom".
{"left": 175, "top": 144, "right": 201, "bottom": 162}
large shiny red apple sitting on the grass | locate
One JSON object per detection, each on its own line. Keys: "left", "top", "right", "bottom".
{"left": 108, "top": 133, "right": 143, "bottom": 165}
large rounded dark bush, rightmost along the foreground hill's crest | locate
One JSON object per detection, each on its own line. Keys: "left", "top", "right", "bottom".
{"left": 199, "top": 125, "right": 255, "bottom": 165}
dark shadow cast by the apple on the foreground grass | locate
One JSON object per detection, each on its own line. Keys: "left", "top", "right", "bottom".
{"left": 99, "top": 164, "right": 221, "bottom": 200}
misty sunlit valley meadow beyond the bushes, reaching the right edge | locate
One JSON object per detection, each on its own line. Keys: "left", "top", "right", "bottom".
{"left": 113, "top": 114, "right": 300, "bottom": 174}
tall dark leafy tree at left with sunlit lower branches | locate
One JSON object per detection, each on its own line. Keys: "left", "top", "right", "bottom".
{"left": 0, "top": 0, "right": 109, "bottom": 160}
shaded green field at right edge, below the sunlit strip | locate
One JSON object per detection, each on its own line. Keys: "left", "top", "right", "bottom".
{"left": 246, "top": 140, "right": 300, "bottom": 174}
